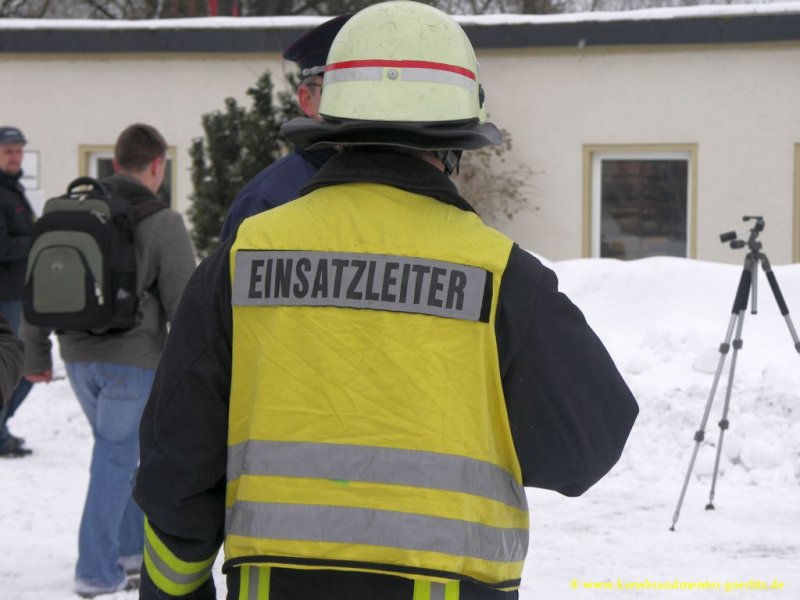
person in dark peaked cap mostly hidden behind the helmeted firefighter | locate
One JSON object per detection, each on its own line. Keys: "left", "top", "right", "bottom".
{"left": 220, "top": 14, "right": 351, "bottom": 240}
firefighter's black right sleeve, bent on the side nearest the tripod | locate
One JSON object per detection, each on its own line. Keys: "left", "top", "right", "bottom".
{"left": 495, "top": 245, "right": 639, "bottom": 496}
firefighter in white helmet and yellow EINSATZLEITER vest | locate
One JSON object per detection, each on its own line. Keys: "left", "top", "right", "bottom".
{"left": 135, "top": 1, "right": 638, "bottom": 600}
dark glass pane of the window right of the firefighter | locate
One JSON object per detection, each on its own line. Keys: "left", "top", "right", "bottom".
{"left": 600, "top": 159, "right": 689, "bottom": 259}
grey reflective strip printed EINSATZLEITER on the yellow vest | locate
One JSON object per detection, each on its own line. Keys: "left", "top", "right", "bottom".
{"left": 232, "top": 250, "right": 491, "bottom": 321}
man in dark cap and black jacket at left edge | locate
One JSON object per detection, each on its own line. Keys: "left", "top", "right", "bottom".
{"left": 0, "top": 126, "right": 33, "bottom": 458}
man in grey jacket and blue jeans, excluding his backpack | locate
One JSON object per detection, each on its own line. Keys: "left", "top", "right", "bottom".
{"left": 23, "top": 124, "right": 195, "bottom": 597}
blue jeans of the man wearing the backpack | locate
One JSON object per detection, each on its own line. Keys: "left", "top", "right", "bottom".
{"left": 65, "top": 362, "right": 155, "bottom": 587}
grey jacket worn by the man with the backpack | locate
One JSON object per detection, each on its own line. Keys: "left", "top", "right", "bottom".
{"left": 21, "top": 175, "right": 196, "bottom": 375}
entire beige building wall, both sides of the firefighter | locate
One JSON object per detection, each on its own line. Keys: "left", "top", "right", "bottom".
{"left": 0, "top": 43, "right": 800, "bottom": 264}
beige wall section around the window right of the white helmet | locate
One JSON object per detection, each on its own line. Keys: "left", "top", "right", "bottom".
{"left": 480, "top": 43, "right": 800, "bottom": 264}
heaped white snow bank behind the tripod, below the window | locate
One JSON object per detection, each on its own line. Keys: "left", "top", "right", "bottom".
{"left": 555, "top": 258, "right": 800, "bottom": 485}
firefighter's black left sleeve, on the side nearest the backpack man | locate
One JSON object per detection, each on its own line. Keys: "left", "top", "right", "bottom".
{"left": 134, "top": 238, "right": 232, "bottom": 598}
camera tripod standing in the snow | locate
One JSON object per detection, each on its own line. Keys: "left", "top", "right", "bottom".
{"left": 670, "top": 216, "right": 800, "bottom": 531}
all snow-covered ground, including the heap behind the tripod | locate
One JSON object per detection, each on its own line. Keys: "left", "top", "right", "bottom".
{"left": 0, "top": 255, "right": 800, "bottom": 600}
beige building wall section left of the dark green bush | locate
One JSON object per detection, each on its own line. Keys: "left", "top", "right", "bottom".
{"left": 6, "top": 54, "right": 284, "bottom": 216}
